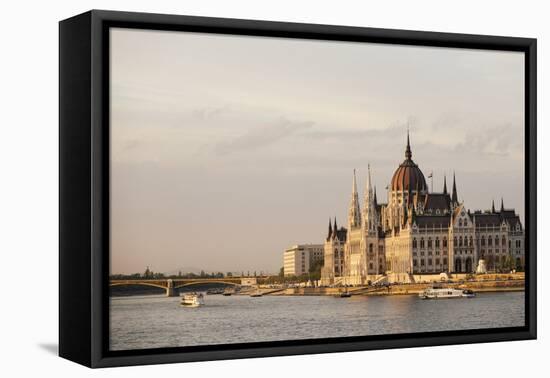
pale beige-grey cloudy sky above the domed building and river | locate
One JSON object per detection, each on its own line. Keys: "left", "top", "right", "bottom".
{"left": 110, "top": 28, "right": 524, "bottom": 273}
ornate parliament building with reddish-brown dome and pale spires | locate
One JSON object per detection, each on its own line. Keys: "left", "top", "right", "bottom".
{"left": 321, "top": 132, "right": 525, "bottom": 285}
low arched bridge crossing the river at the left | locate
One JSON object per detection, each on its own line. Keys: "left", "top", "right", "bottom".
{"left": 109, "top": 277, "right": 257, "bottom": 297}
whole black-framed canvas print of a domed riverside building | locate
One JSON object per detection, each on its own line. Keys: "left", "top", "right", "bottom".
{"left": 59, "top": 11, "right": 536, "bottom": 367}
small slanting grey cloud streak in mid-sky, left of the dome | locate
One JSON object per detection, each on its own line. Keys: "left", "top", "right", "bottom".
{"left": 215, "top": 118, "right": 313, "bottom": 155}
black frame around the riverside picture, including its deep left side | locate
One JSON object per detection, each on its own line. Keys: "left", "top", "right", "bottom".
{"left": 59, "top": 10, "right": 537, "bottom": 367}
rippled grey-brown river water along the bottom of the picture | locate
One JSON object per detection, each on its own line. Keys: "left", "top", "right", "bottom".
{"left": 110, "top": 292, "right": 525, "bottom": 350}
